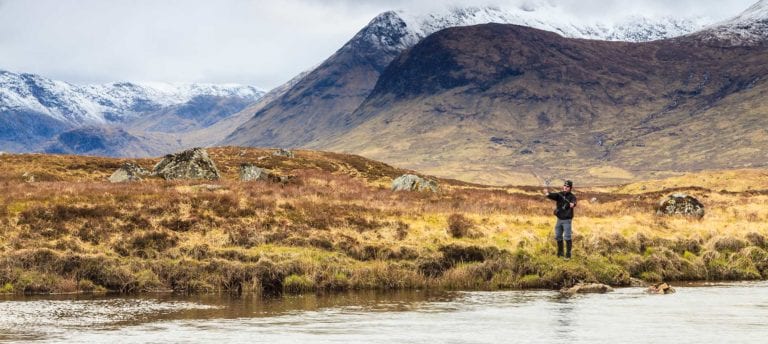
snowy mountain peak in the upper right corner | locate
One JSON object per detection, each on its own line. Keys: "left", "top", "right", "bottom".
{"left": 692, "top": 0, "right": 768, "bottom": 46}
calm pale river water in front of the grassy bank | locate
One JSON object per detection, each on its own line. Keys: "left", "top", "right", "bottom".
{"left": 0, "top": 282, "right": 768, "bottom": 343}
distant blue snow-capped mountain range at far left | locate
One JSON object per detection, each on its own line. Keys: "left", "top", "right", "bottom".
{"left": 0, "top": 70, "right": 264, "bottom": 156}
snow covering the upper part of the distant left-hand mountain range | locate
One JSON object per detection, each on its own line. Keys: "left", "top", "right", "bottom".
{"left": 0, "top": 70, "right": 264, "bottom": 125}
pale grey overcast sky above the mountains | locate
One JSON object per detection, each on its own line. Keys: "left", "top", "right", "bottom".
{"left": 0, "top": 0, "right": 757, "bottom": 90}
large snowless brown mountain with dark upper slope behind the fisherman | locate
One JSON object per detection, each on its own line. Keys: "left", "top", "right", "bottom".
{"left": 315, "top": 24, "right": 768, "bottom": 183}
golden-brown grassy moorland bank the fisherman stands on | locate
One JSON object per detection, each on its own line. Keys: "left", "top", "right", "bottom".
{"left": 0, "top": 148, "right": 768, "bottom": 293}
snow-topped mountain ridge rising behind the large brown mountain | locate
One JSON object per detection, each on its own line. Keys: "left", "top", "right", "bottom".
{"left": 223, "top": 7, "right": 706, "bottom": 147}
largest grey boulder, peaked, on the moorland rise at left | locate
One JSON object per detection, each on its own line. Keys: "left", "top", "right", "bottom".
{"left": 153, "top": 148, "right": 221, "bottom": 180}
